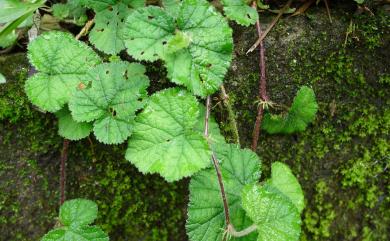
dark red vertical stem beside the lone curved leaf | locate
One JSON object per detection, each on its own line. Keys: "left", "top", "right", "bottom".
{"left": 251, "top": 1, "right": 269, "bottom": 151}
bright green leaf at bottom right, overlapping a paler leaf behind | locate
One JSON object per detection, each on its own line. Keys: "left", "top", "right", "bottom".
{"left": 242, "top": 184, "right": 301, "bottom": 241}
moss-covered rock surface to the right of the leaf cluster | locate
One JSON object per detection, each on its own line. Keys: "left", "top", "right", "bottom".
{"left": 221, "top": 6, "right": 390, "bottom": 240}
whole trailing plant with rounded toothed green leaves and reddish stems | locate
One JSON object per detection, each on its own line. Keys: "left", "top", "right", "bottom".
{"left": 18, "top": 0, "right": 317, "bottom": 241}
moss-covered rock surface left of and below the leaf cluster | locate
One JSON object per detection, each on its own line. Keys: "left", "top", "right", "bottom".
{"left": 0, "top": 54, "right": 187, "bottom": 241}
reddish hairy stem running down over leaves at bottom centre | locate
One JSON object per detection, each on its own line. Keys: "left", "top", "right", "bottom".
{"left": 204, "top": 96, "right": 230, "bottom": 231}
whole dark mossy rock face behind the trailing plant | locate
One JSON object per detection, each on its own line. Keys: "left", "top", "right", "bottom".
{"left": 0, "top": 4, "right": 390, "bottom": 241}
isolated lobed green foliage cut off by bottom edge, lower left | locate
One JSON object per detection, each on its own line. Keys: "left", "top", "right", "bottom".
{"left": 41, "top": 199, "right": 109, "bottom": 241}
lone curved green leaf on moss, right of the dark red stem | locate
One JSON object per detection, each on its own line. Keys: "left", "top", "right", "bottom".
{"left": 262, "top": 86, "right": 318, "bottom": 134}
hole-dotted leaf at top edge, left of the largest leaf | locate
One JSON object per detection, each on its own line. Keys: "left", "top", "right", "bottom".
{"left": 83, "top": 0, "right": 145, "bottom": 54}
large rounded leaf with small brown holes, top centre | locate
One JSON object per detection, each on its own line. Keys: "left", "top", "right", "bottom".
{"left": 124, "top": 0, "right": 233, "bottom": 96}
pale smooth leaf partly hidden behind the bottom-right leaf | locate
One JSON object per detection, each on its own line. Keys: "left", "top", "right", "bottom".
{"left": 269, "top": 162, "right": 305, "bottom": 212}
